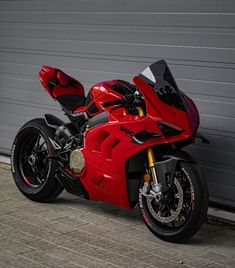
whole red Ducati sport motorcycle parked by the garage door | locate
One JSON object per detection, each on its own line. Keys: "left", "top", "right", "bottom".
{"left": 11, "top": 60, "right": 208, "bottom": 242}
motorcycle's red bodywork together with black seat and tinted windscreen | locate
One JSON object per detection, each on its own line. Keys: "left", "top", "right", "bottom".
{"left": 39, "top": 61, "right": 199, "bottom": 208}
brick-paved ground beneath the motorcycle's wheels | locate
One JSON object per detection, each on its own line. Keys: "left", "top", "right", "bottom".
{"left": 0, "top": 164, "right": 235, "bottom": 268}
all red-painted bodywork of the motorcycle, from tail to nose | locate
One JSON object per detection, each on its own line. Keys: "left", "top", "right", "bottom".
{"left": 39, "top": 63, "right": 199, "bottom": 208}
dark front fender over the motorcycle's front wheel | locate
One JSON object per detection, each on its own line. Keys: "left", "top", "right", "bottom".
{"left": 155, "top": 150, "right": 196, "bottom": 192}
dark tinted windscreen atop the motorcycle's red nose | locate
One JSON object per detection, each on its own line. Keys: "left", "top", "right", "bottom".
{"left": 139, "top": 60, "right": 186, "bottom": 111}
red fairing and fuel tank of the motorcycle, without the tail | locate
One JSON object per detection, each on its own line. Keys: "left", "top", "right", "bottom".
{"left": 72, "top": 77, "right": 198, "bottom": 208}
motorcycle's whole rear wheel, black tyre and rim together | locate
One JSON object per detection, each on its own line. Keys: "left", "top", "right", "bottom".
{"left": 11, "top": 118, "right": 63, "bottom": 202}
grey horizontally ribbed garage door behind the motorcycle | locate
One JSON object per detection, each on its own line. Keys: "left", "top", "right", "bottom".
{"left": 0, "top": 0, "right": 235, "bottom": 206}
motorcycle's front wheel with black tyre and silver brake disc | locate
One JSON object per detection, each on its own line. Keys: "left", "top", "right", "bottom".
{"left": 139, "top": 162, "right": 208, "bottom": 243}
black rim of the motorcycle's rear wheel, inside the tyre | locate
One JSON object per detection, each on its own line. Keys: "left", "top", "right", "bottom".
{"left": 18, "top": 130, "right": 51, "bottom": 188}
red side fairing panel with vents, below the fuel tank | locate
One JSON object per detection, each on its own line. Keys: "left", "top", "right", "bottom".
{"left": 80, "top": 114, "right": 188, "bottom": 207}
